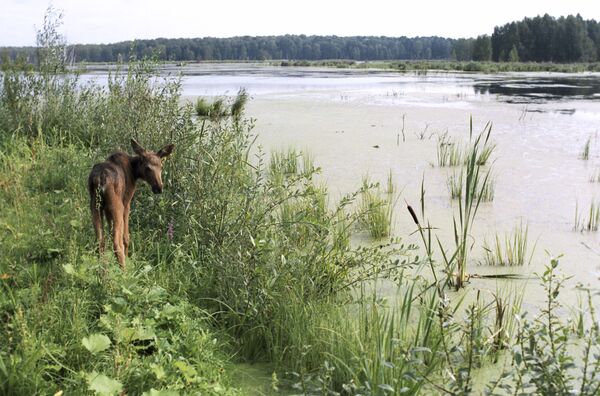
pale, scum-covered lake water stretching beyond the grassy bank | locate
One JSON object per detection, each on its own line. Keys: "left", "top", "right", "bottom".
{"left": 176, "top": 66, "right": 600, "bottom": 314}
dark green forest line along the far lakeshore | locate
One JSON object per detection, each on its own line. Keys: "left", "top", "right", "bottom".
{"left": 4, "top": 15, "right": 600, "bottom": 63}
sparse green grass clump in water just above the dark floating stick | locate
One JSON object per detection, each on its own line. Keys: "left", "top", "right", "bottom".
{"left": 483, "top": 223, "right": 535, "bottom": 267}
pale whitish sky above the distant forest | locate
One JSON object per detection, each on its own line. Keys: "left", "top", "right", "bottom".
{"left": 0, "top": 0, "right": 600, "bottom": 46}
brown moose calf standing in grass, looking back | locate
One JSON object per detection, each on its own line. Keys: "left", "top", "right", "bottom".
{"left": 88, "top": 139, "right": 175, "bottom": 270}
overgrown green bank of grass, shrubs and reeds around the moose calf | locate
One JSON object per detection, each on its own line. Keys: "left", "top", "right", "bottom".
{"left": 0, "top": 41, "right": 600, "bottom": 395}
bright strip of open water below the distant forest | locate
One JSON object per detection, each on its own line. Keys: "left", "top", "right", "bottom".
{"left": 77, "top": 63, "right": 600, "bottom": 103}
